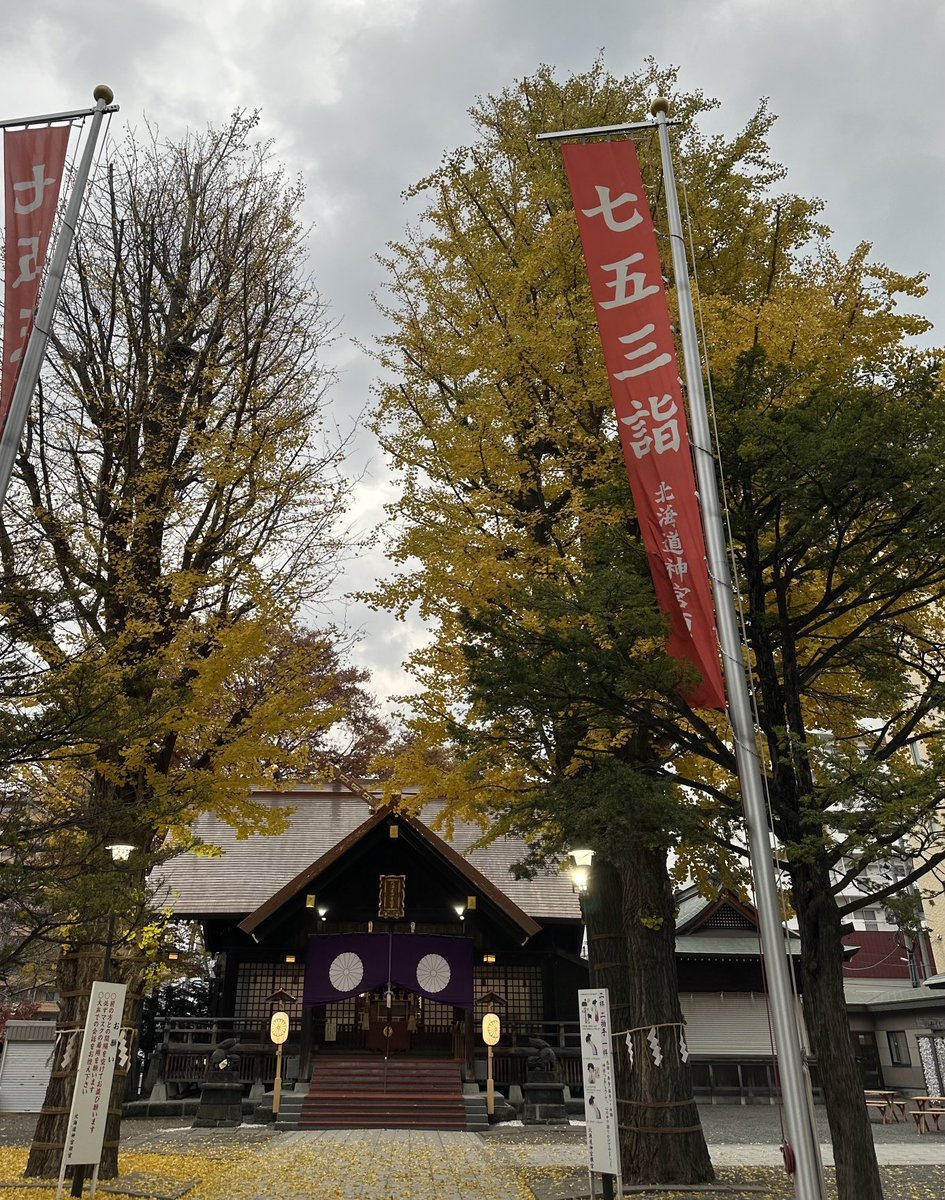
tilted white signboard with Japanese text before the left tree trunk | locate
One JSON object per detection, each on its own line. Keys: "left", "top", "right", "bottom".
{"left": 62, "top": 983, "right": 127, "bottom": 1166}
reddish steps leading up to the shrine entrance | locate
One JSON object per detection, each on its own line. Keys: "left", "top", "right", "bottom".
{"left": 298, "top": 1057, "right": 469, "bottom": 1129}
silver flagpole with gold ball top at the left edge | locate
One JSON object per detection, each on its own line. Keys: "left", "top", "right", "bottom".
{"left": 0, "top": 84, "right": 115, "bottom": 505}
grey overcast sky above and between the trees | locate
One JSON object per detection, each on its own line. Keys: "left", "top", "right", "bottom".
{"left": 0, "top": 0, "right": 945, "bottom": 697}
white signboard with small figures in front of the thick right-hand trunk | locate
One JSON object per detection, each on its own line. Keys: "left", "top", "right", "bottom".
{"left": 578, "top": 988, "right": 620, "bottom": 1176}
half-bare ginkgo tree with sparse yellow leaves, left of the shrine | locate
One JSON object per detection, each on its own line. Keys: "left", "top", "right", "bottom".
{"left": 0, "top": 114, "right": 379, "bottom": 1175}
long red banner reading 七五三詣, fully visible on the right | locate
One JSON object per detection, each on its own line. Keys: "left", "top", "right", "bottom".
{"left": 562, "top": 142, "right": 726, "bottom": 708}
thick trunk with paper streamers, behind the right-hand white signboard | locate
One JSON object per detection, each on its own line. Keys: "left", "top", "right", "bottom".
{"left": 585, "top": 846, "right": 715, "bottom": 1184}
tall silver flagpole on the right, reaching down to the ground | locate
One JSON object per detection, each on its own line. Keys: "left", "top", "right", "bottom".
{"left": 650, "top": 98, "right": 826, "bottom": 1200}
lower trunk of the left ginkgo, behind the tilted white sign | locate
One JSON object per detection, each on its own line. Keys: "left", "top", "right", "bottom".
{"left": 24, "top": 948, "right": 144, "bottom": 1180}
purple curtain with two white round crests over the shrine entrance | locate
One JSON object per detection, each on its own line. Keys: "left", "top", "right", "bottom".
{"left": 305, "top": 934, "right": 473, "bottom": 1008}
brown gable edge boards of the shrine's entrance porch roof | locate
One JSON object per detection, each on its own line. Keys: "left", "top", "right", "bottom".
{"left": 240, "top": 805, "right": 541, "bottom": 938}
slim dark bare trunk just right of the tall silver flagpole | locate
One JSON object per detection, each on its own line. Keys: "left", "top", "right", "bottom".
{"left": 791, "top": 864, "right": 883, "bottom": 1200}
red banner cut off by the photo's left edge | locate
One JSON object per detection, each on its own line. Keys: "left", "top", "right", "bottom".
{"left": 0, "top": 125, "right": 70, "bottom": 433}
